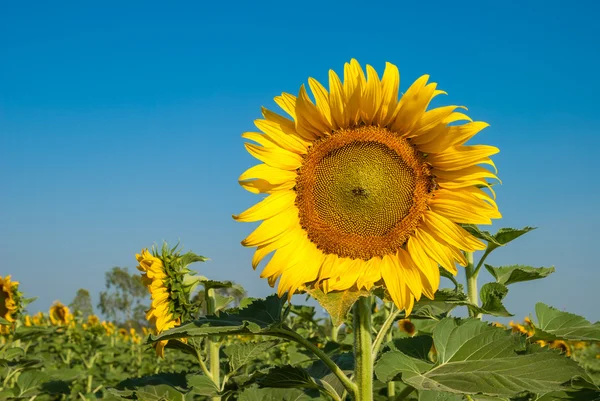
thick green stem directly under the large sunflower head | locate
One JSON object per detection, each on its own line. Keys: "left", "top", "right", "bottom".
{"left": 352, "top": 297, "right": 373, "bottom": 401}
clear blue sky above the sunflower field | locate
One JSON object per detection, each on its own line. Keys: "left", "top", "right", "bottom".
{"left": 0, "top": 0, "right": 600, "bottom": 320}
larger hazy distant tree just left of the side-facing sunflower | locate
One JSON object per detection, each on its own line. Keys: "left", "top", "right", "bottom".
{"left": 98, "top": 266, "right": 149, "bottom": 328}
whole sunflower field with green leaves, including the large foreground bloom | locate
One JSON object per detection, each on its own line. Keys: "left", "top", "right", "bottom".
{"left": 0, "top": 60, "right": 600, "bottom": 401}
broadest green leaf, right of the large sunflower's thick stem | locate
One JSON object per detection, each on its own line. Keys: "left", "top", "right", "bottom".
{"left": 375, "top": 318, "right": 588, "bottom": 396}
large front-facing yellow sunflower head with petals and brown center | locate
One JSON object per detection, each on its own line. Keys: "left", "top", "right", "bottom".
{"left": 233, "top": 60, "right": 501, "bottom": 313}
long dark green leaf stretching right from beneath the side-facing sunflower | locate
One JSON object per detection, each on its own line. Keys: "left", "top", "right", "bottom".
{"left": 149, "top": 295, "right": 285, "bottom": 343}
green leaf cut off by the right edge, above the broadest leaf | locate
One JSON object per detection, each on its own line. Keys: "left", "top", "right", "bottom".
{"left": 535, "top": 302, "right": 600, "bottom": 341}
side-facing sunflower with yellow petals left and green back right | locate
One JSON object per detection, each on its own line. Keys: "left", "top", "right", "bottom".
{"left": 136, "top": 244, "right": 206, "bottom": 357}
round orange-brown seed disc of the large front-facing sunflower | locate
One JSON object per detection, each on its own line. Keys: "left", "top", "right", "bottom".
{"left": 296, "top": 126, "right": 433, "bottom": 259}
